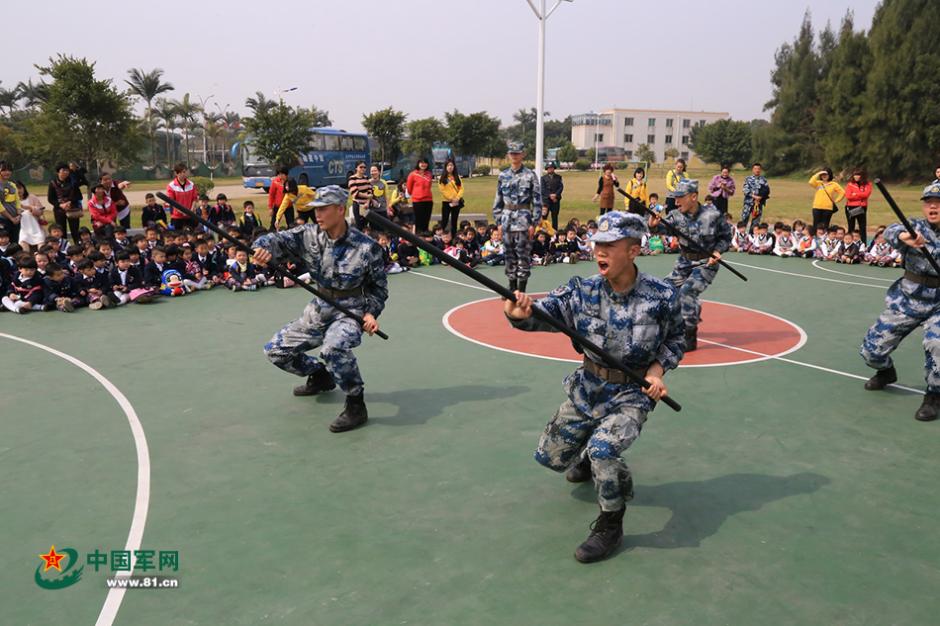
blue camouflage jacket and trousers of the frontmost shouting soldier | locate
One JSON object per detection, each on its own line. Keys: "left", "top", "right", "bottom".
{"left": 510, "top": 272, "right": 684, "bottom": 511}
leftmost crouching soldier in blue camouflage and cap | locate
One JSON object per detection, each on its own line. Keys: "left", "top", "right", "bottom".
{"left": 254, "top": 185, "right": 388, "bottom": 433}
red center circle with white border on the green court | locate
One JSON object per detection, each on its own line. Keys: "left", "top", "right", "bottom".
{"left": 442, "top": 294, "right": 806, "bottom": 367}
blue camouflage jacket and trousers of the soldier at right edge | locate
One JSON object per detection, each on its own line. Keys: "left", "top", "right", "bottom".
{"left": 859, "top": 219, "right": 940, "bottom": 393}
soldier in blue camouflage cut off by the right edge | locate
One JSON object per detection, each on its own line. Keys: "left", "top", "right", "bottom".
{"left": 861, "top": 182, "right": 940, "bottom": 422}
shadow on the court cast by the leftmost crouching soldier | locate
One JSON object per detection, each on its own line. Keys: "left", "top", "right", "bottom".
{"left": 317, "top": 385, "right": 529, "bottom": 426}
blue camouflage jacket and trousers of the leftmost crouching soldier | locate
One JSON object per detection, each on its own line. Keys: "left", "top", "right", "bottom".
{"left": 254, "top": 223, "right": 388, "bottom": 395}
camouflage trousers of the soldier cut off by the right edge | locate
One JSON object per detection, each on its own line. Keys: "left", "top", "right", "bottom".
{"left": 860, "top": 279, "right": 940, "bottom": 393}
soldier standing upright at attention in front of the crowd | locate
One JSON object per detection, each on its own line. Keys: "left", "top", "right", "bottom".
{"left": 493, "top": 144, "right": 542, "bottom": 291}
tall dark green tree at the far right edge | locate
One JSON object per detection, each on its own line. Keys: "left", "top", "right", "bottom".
{"left": 861, "top": 0, "right": 940, "bottom": 180}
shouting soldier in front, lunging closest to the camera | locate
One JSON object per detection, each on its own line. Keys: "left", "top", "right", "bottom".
{"left": 504, "top": 211, "right": 683, "bottom": 563}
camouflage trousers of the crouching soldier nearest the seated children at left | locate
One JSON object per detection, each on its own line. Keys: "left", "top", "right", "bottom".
{"left": 264, "top": 300, "right": 370, "bottom": 395}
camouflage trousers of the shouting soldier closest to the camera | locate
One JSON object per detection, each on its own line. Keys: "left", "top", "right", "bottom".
{"left": 535, "top": 400, "right": 646, "bottom": 511}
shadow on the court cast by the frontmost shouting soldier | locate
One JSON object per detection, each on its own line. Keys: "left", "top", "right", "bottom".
{"left": 574, "top": 472, "right": 831, "bottom": 550}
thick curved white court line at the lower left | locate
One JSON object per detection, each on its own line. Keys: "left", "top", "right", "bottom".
{"left": 0, "top": 333, "right": 150, "bottom": 626}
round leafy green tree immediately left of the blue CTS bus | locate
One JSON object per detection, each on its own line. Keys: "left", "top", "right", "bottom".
{"left": 245, "top": 99, "right": 316, "bottom": 167}
